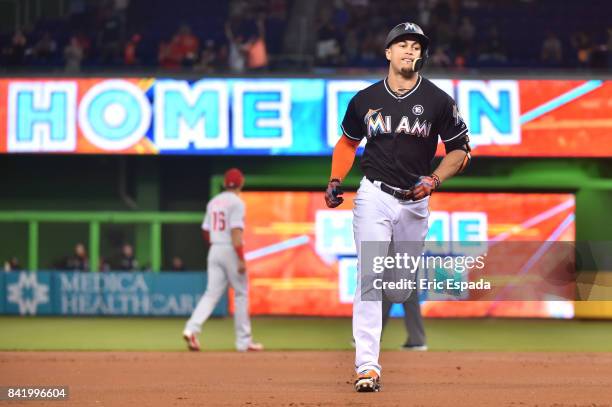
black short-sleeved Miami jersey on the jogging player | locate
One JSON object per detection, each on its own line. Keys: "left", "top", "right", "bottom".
{"left": 342, "top": 75, "right": 468, "bottom": 189}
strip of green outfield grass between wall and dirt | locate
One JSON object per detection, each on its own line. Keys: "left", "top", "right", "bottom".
{"left": 0, "top": 317, "right": 612, "bottom": 352}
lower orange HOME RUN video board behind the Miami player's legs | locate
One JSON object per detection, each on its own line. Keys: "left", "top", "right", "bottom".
{"left": 242, "top": 191, "right": 575, "bottom": 317}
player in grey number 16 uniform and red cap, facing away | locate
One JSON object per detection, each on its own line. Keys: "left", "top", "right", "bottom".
{"left": 183, "top": 168, "right": 263, "bottom": 352}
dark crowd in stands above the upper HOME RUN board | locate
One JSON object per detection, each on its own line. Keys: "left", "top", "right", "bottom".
{"left": 0, "top": 0, "right": 612, "bottom": 74}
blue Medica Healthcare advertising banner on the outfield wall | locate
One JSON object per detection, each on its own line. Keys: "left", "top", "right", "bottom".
{"left": 0, "top": 271, "right": 227, "bottom": 316}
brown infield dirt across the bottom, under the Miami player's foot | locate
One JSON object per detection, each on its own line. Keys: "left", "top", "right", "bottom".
{"left": 0, "top": 351, "right": 612, "bottom": 407}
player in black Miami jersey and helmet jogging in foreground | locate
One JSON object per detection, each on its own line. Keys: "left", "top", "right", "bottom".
{"left": 325, "top": 22, "right": 470, "bottom": 392}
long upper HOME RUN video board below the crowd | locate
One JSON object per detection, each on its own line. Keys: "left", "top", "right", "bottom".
{"left": 0, "top": 78, "right": 612, "bottom": 157}
